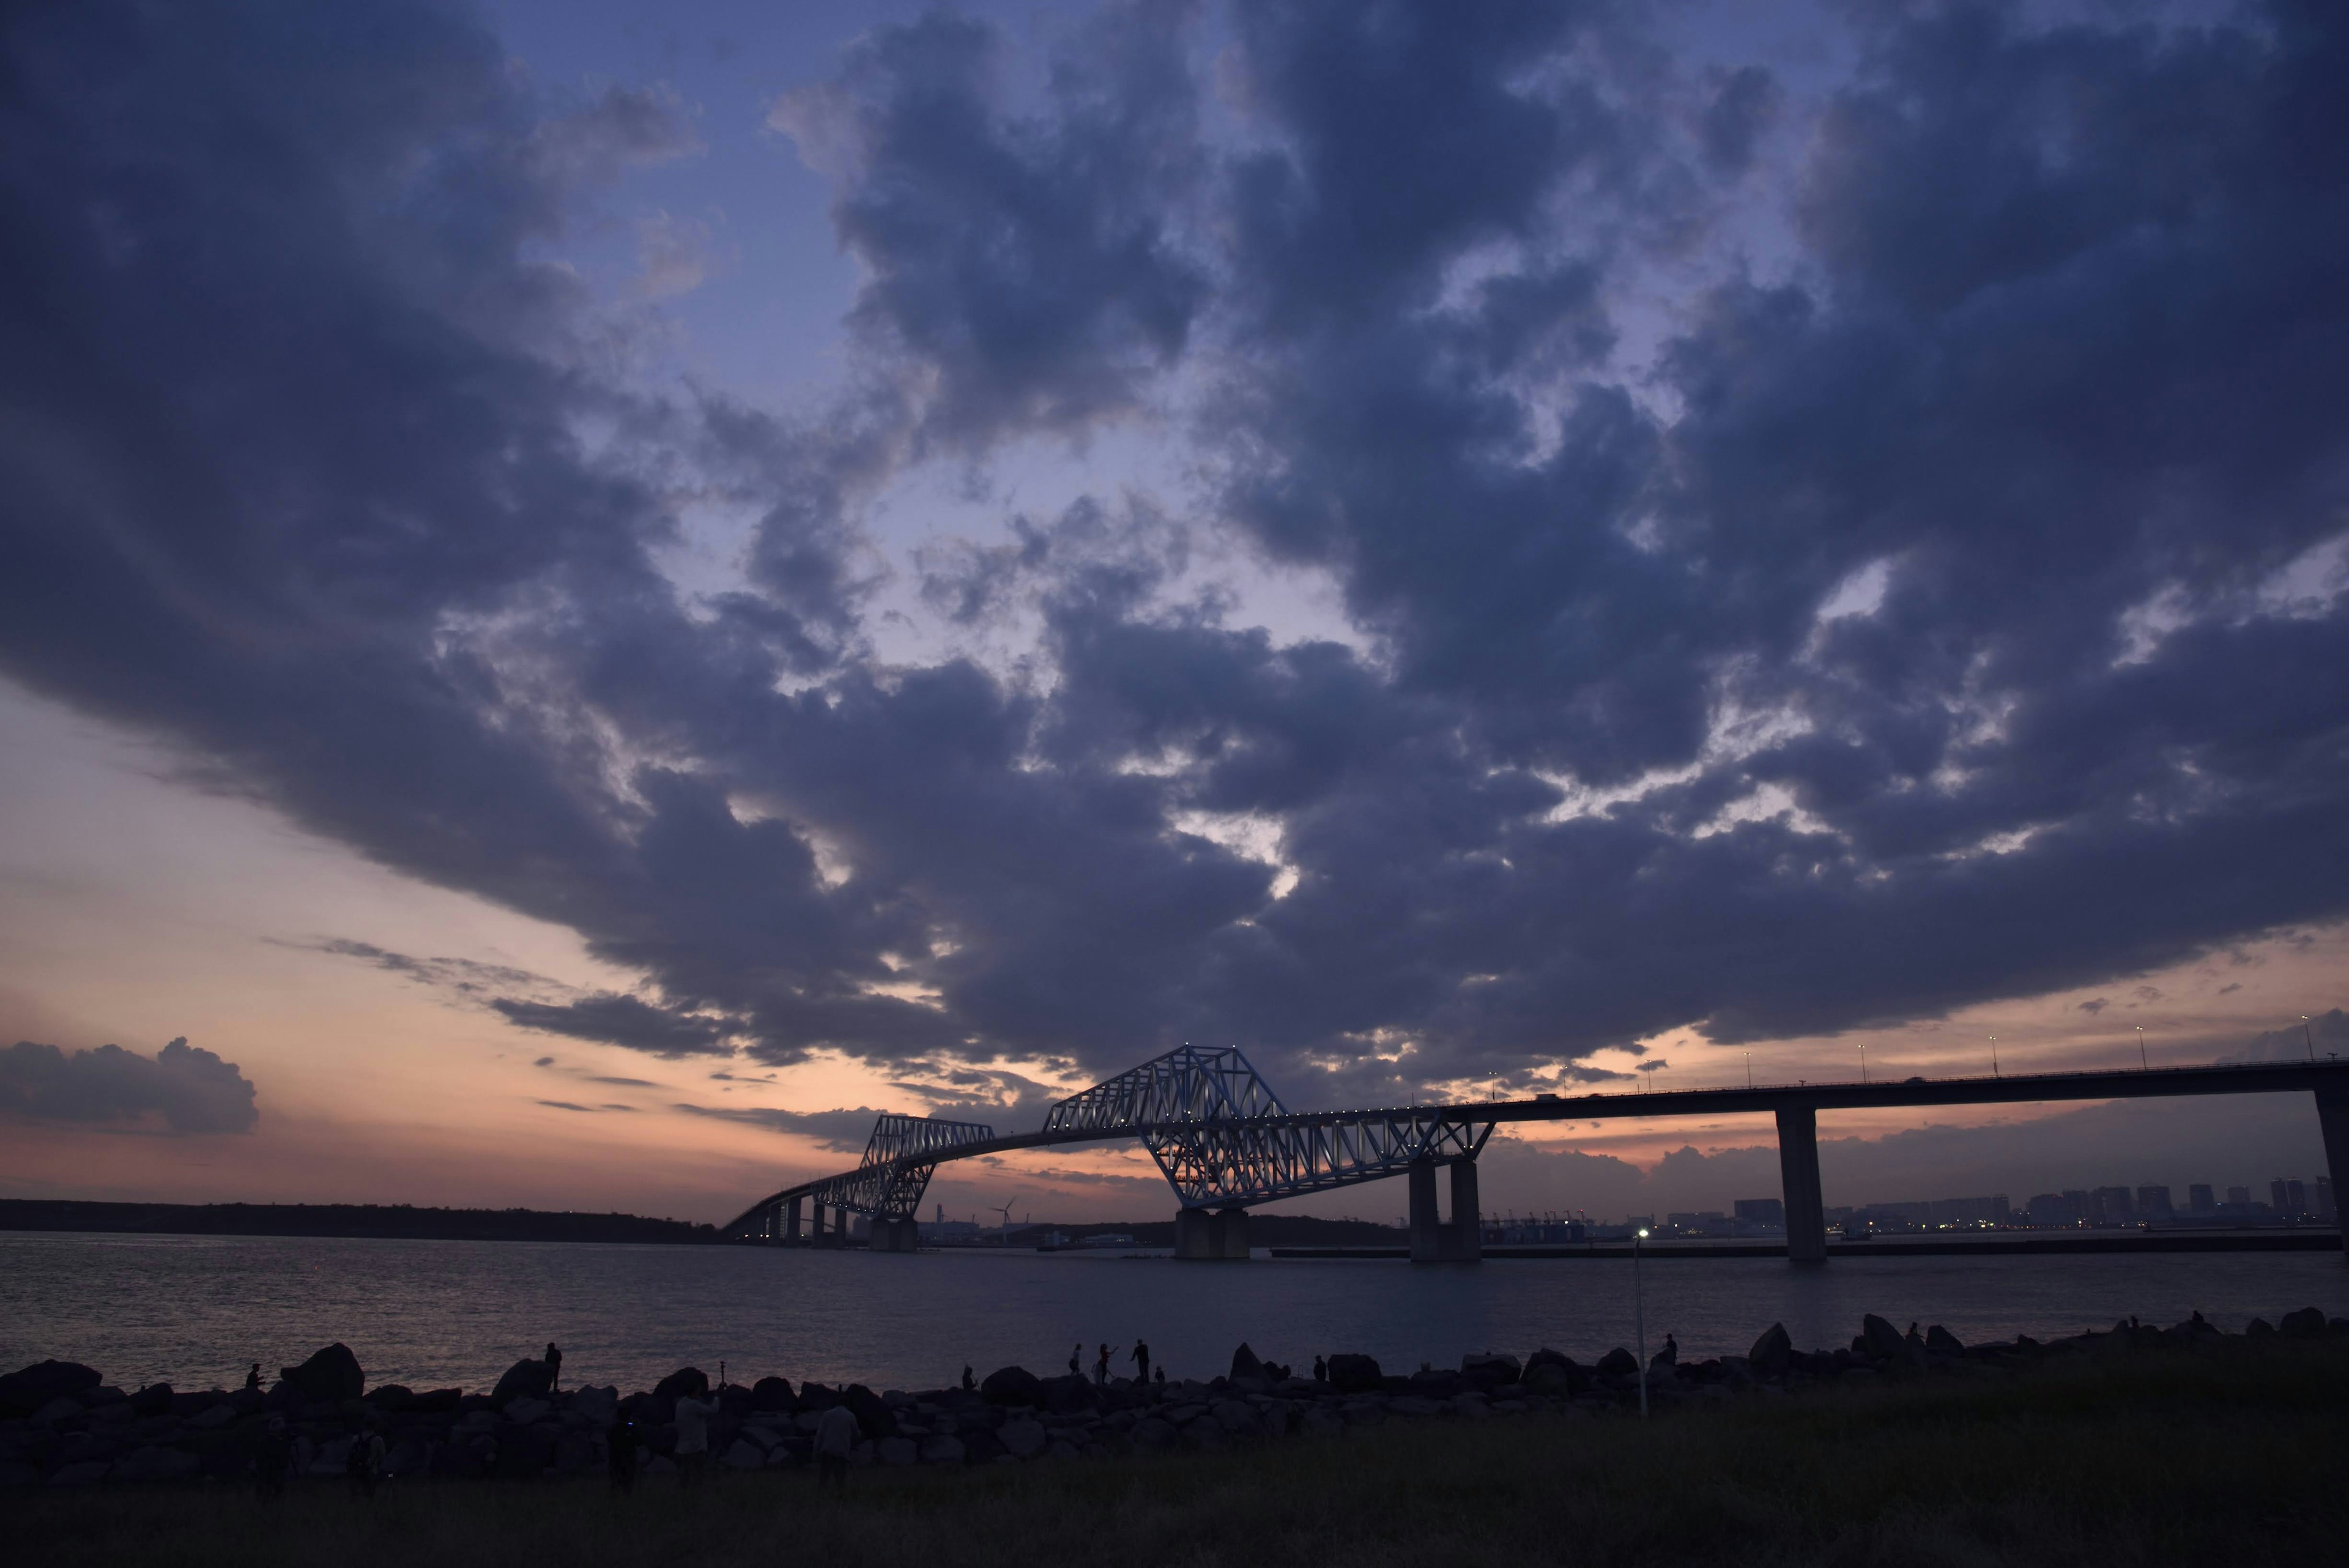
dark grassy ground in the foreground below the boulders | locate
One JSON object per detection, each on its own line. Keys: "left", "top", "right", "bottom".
{"left": 23, "top": 1340, "right": 2349, "bottom": 1568}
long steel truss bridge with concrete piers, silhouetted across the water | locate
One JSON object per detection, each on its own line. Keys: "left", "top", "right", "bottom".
{"left": 721, "top": 1046, "right": 2349, "bottom": 1262}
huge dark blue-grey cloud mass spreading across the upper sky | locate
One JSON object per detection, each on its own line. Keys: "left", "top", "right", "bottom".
{"left": 0, "top": 2, "right": 2349, "bottom": 1128}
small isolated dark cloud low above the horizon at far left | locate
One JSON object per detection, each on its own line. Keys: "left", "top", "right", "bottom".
{"left": 0, "top": 1039, "right": 261, "bottom": 1133}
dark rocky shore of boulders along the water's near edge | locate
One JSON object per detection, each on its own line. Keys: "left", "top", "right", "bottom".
{"left": 0, "top": 1307, "right": 2349, "bottom": 1488}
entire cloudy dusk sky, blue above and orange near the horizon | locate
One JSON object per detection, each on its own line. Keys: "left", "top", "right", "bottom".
{"left": 0, "top": 0, "right": 2349, "bottom": 1220}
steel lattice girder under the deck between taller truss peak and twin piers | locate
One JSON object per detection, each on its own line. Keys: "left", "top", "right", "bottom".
{"left": 1141, "top": 1110, "right": 1494, "bottom": 1208}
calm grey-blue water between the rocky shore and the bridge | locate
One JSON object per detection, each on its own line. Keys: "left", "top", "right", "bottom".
{"left": 0, "top": 1234, "right": 2349, "bottom": 1389}
